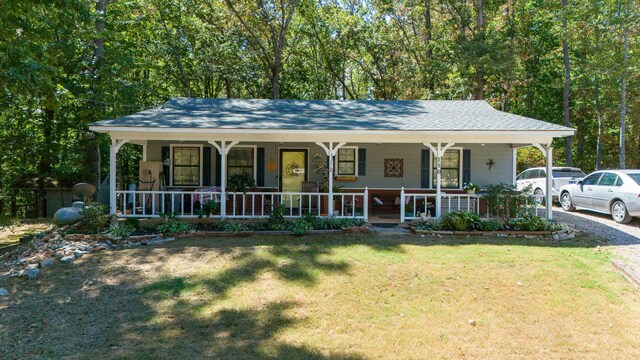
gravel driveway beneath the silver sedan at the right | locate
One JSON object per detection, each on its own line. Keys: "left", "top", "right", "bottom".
{"left": 553, "top": 207, "right": 640, "bottom": 271}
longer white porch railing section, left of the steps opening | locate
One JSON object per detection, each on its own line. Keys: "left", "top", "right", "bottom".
{"left": 116, "top": 189, "right": 369, "bottom": 221}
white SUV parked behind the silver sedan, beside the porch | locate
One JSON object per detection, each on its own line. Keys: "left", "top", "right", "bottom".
{"left": 516, "top": 167, "right": 585, "bottom": 202}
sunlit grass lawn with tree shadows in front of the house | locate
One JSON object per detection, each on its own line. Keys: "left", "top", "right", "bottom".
{"left": 0, "top": 235, "right": 640, "bottom": 359}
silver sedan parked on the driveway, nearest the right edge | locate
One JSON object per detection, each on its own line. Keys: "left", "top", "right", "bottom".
{"left": 560, "top": 170, "right": 640, "bottom": 224}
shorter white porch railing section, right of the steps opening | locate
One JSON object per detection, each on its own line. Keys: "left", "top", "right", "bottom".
{"left": 400, "top": 189, "right": 480, "bottom": 222}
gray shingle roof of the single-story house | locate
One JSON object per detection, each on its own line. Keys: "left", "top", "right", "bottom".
{"left": 87, "top": 98, "right": 571, "bottom": 131}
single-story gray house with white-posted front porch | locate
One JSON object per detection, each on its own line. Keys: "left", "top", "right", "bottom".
{"left": 90, "top": 98, "right": 574, "bottom": 221}
